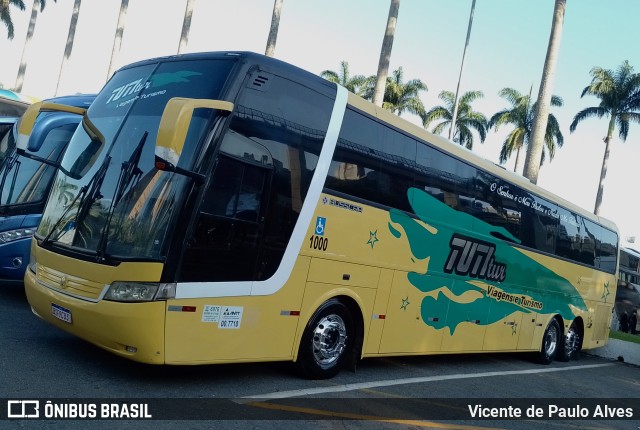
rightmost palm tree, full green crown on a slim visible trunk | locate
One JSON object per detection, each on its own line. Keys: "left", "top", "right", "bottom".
{"left": 569, "top": 61, "right": 640, "bottom": 215}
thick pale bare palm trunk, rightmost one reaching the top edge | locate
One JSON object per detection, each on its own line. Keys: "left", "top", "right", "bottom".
{"left": 524, "top": 0, "right": 567, "bottom": 184}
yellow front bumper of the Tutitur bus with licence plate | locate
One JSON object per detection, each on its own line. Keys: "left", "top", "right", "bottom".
{"left": 24, "top": 269, "right": 166, "bottom": 364}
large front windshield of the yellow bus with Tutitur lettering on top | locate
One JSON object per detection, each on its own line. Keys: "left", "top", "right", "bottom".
{"left": 37, "top": 60, "right": 233, "bottom": 260}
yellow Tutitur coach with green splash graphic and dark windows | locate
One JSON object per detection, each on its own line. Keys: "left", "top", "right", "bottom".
{"left": 26, "top": 52, "right": 618, "bottom": 378}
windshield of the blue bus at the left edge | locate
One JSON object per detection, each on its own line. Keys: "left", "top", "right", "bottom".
{"left": 0, "top": 124, "right": 76, "bottom": 207}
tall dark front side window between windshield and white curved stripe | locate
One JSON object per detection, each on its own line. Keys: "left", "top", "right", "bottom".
{"left": 181, "top": 72, "right": 333, "bottom": 281}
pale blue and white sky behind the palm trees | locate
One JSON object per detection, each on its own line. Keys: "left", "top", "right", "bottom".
{"left": 0, "top": 0, "right": 640, "bottom": 249}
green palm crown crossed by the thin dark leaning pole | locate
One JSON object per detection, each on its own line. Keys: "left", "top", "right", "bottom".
{"left": 422, "top": 91, "right": 487, "bottom": 149}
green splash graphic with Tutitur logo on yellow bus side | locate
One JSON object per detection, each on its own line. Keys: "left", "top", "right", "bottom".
{"left": 389, "top": 188, "right": 586, "bottom": 334}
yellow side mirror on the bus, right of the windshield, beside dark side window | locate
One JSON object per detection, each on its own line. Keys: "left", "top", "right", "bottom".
{"left": 155, "top": 97, "right": 233, "bottom": 180}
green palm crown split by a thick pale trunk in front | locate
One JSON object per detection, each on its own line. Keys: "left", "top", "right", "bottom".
{"left": 488, "top": 88, "right": 564, "bottom": 172}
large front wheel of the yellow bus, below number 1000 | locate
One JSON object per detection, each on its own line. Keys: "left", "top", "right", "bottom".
{"left": 296, "top": 299, "right": 355, "bottom": 379}
